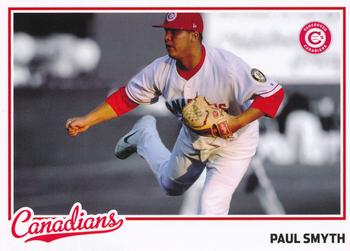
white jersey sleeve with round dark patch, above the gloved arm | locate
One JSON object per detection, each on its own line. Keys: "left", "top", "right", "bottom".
{"left": 231, "top": 58, "right": 282, "bottom": 105}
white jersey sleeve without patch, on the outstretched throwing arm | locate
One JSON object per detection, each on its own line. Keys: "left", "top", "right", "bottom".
{"left": 125, "top": 56, "right": 162, "bottom": 104}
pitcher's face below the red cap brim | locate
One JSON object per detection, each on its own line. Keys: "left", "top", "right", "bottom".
{"left": 164, "top": 29, "right": 192, "bottom": 59}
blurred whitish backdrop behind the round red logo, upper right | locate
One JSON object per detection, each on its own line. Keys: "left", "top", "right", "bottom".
{"left": 205, "top": 11, "right": 342, "bottom": 84}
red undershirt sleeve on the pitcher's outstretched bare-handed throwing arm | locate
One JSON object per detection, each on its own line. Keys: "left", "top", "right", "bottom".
{"left": 106, "top": 86, "right": 138, "bottom": 116}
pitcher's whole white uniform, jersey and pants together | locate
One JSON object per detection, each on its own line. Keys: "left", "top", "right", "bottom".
{"left": 117, "top": 45, "right": 281, "bottom": 215}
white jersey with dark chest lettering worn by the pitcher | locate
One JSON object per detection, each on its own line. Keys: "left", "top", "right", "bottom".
{"left": 126, "top": 47, "right": 281, "bottom": 145}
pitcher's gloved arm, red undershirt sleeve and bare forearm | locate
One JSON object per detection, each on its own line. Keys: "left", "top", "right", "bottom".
{"left": 228, "top": 88, "right": 284, "bottom": 133}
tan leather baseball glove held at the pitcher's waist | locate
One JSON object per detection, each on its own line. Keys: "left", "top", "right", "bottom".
{"left": 182, "top": 96, "right": 232, "bottom": 138}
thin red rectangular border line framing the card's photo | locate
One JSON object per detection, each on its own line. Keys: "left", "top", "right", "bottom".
{"left": 8, "top": 7, "right": 346, "bottom": 221}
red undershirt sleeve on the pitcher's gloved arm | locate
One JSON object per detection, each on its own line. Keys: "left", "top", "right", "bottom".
{"left": 250, "top": 88, "right": 284, "bottom": 118}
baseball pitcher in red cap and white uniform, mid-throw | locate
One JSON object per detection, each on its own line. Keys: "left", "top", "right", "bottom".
{"left": 66, "top": 13, "right": 284, "bottom": 215}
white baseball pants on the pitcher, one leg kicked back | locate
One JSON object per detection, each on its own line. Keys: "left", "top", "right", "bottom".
{"left": 137, "top": 123, "right": 259, "bottom": 215}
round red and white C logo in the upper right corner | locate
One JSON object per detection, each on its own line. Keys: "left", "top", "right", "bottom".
{"left": 299, "top": 22, "right": 331, "bottom": 54}
